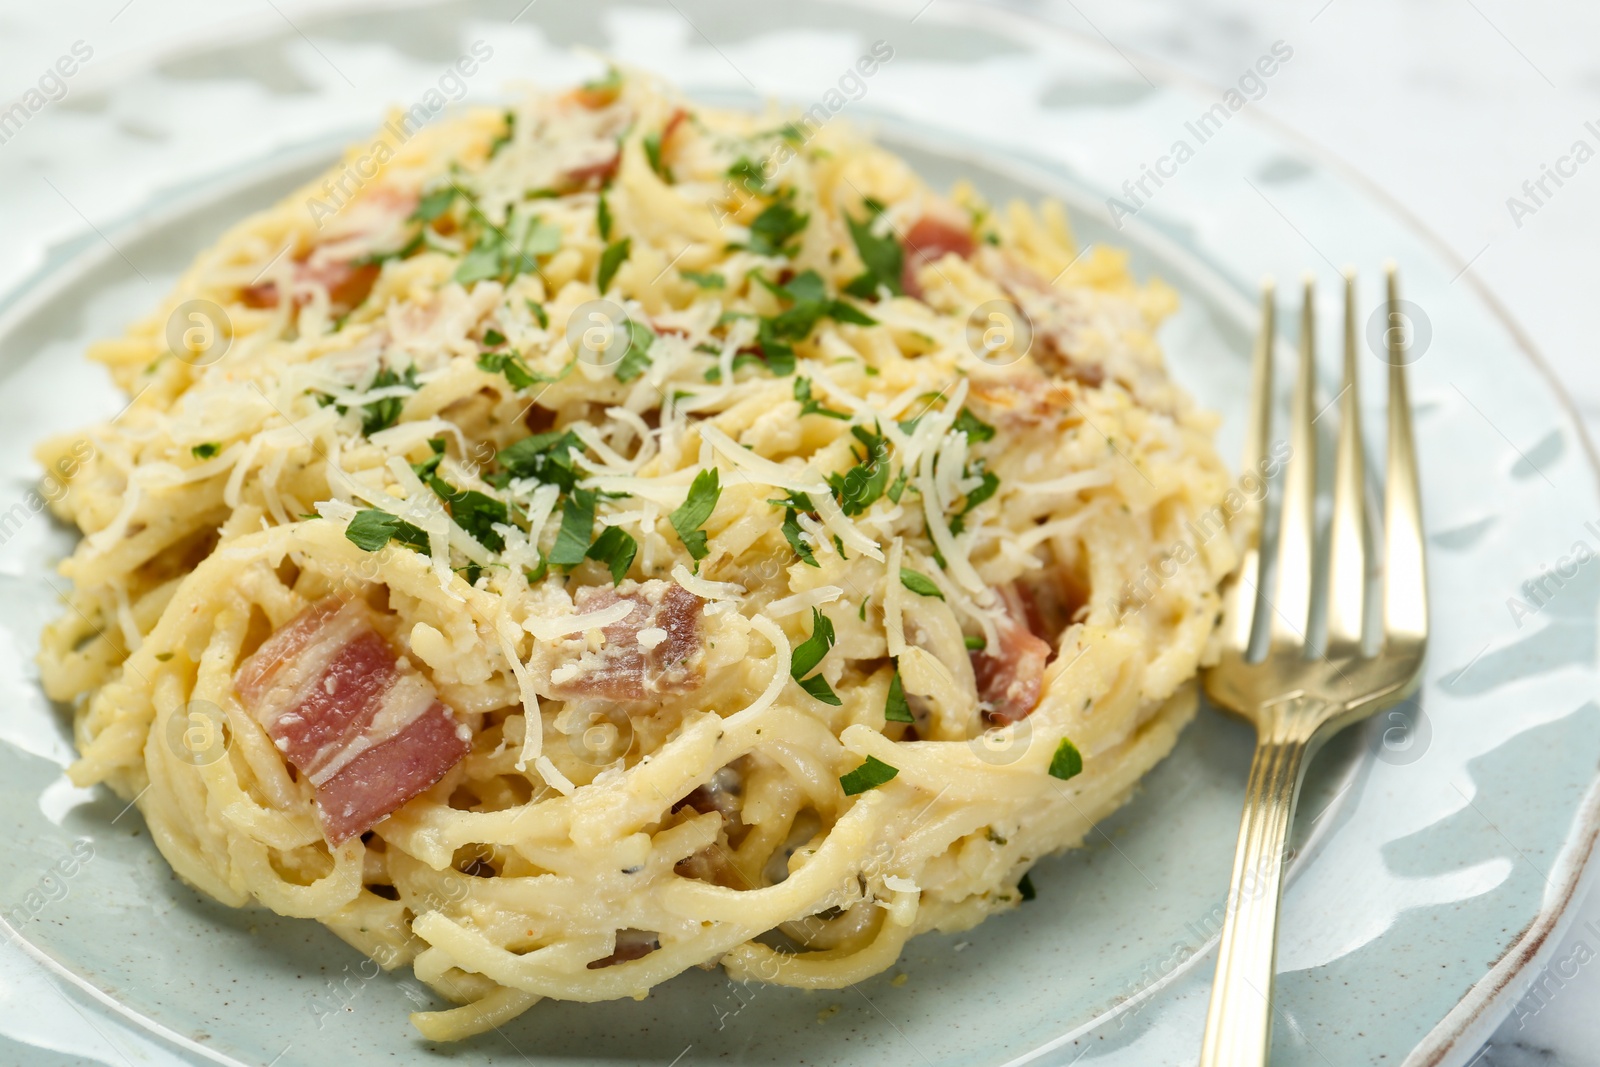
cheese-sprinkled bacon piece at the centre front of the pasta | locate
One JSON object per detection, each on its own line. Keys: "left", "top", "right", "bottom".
{"left": 552, "top": 579, "right": 704, "bottom": 701}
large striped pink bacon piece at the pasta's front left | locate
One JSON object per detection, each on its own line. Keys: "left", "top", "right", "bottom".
{"left": 234, "top": 598, "right": 470, "bottom": 846}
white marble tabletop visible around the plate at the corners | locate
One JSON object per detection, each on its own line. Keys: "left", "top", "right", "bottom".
{"left": 0, "top": 0, "right": 1600, "bottom": 1067}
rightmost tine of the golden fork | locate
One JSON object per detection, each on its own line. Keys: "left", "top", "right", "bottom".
{"left": 1384, "top": 262, "right": 1427, "bottom": 654}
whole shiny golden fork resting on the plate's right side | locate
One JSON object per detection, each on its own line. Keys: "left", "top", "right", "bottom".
{"left": 1200, "top": 266, "right": 1427, "bottom": 1067}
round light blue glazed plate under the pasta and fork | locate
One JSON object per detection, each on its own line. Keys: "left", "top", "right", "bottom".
{"left": 0, "top": 0, "right": 1600, "bottom": 1067}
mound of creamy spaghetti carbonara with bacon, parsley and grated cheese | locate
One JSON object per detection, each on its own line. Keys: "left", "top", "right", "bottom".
{"left": 40, "top": 64, "right": 1235, "bottom": 1038}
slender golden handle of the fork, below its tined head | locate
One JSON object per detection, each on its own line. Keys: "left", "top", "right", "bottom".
{"left": 1200, "top": 715, "right": 1314, "bottom": 1067}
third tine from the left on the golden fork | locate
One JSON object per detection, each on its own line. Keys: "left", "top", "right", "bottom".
{"left": 1328, "top": 270, "right": 1366, "bottom": 656}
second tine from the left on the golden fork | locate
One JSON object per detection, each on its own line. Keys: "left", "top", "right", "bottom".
{"left": 1269, "top": 275, "right": 1317, "bottom": 651}
